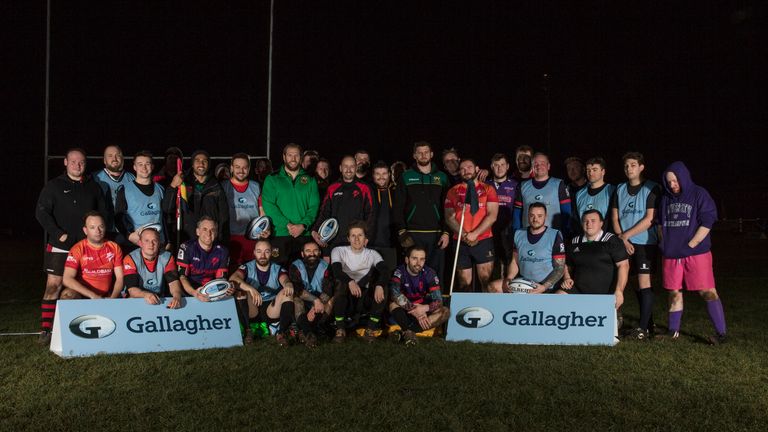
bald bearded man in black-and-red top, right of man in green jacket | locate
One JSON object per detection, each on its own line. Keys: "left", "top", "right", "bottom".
{"left": 312, "top": 156, "right": 376, "bottom": 257}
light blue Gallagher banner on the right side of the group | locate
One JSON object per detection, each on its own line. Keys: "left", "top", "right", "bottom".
{"left": 446, "top": 293, "right": 616, "bottom": 345}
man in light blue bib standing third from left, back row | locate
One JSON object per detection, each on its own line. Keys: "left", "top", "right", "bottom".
{"left": 115, "top": 150, "right": 168, "bottom": 246}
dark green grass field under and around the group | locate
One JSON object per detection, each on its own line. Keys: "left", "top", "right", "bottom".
{"left": 0, "top": 233, "right": 768, "bottom": 431}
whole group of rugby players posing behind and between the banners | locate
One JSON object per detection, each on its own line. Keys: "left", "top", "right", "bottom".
{"left": 36, "top": 141, "right": 726, "bottom": 347}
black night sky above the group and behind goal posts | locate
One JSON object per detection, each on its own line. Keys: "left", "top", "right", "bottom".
{"left": 0, "top": 0, "right": 768, "bottom": 235}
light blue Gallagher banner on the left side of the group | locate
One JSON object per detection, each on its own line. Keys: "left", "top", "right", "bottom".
{"left": 51, "top": 298, "right": 242, "bottom": 357}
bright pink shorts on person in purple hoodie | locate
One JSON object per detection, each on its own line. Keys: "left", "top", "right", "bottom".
{"left": 661, "top": 252, "right": 715, "bottom": 291}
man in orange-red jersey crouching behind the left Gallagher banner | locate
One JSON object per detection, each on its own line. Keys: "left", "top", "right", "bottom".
{"left": 60, "top": 211, "right": 123, "bottom": 300}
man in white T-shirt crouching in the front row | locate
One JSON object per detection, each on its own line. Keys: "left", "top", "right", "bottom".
{"left": 331, "top": 221, "right": 389, "bottom": 343}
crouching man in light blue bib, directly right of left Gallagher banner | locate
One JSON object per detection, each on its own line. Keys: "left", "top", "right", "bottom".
{"left": 229, "top": 239, "right": 295, "bottom": 346}
